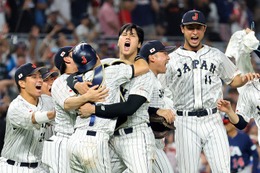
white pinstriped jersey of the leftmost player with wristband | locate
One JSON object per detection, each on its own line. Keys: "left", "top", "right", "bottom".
{"left": 1, "top": 95, "right": 53, "bottom": 162}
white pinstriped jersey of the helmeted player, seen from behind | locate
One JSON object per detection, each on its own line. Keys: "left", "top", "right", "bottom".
{"left": 75, "top": 63, "right": 133, "bottom": 134}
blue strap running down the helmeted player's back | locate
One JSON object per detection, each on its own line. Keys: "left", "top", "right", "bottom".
{"left": 89, "top": 65, "right": 106, "bottom": 126}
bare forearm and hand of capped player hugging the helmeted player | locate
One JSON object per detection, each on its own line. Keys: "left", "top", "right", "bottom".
{"left": 64, "top": 85, "right": 108, "bottom": 110}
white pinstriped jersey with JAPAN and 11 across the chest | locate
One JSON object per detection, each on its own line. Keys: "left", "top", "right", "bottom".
{"left": 165, "top": 45, "right": 240, "bottom": 111}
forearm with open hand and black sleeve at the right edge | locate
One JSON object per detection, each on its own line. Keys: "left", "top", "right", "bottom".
{"left": 217, "top": 99, "right": 247, "bottom": 130}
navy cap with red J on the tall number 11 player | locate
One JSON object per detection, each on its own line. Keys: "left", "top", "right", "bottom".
{"left": 181, "top": 10, "right": 206, "bottom": 26}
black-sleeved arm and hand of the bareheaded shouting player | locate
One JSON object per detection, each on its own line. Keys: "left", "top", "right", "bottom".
{"left": 80, "top": 95, "right": 146, "bottom": 118}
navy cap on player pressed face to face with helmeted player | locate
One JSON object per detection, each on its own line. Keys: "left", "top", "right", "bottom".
{"left": 54, "top": 46, "right": 73, "bottom": 73}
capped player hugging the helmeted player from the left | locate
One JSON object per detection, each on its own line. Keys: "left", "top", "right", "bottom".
{"left": 42, "top": 46, "right": 107, "bottom": 173}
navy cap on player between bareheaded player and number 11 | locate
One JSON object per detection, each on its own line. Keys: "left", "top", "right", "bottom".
{"left": 139, "top": 40, "right": 176, "bottom": 60}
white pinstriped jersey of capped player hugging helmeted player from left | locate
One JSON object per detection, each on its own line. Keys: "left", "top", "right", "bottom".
{"left": 51, "top": 74, "right": 76, "bottom": 135}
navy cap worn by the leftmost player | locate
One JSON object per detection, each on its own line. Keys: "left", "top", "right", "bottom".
{"left": 14, "top": 63, "right": 42, "bottom": 86}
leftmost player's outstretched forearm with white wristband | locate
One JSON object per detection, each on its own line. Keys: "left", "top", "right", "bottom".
{"left": 32, "top": 111, "right": 56, "bottom": 124}
